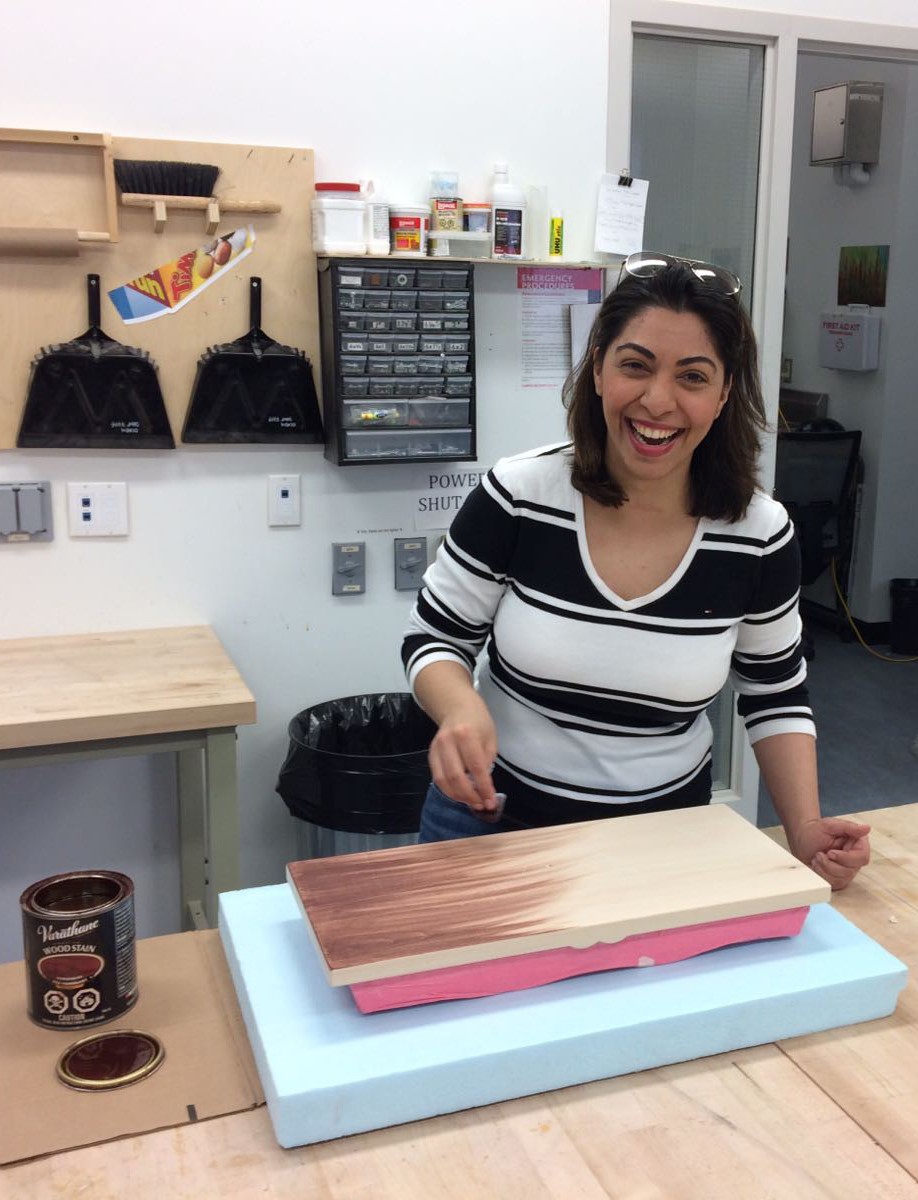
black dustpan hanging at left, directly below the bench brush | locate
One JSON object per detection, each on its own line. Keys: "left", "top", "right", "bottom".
{"left": 16, "top": 275, "right": 175, "bottom": 450}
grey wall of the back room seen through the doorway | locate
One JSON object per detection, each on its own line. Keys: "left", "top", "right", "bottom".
{"left": 784, "top": 55, "right": 918, "bottom": 622}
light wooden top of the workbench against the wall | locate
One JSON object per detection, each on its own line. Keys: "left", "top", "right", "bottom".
{"left": 0, "top": 625, "right": 256, "bottom": 750}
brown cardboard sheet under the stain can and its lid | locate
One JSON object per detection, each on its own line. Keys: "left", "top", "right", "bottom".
{"left": 0, "top": 930, "right": 264, "bottom": 1163}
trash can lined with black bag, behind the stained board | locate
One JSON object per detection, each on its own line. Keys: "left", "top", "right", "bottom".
{"left": 276, "top": 692, "right": 437, "bottom": 858}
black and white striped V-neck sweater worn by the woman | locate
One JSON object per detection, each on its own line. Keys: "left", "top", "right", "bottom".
{"left": 402, "top": 443, "right": 815, "bottom": 824}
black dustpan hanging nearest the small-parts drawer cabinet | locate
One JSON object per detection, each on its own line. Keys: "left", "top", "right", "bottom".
{"left": 181, "top": 276, "right": 324, "bottom": 443}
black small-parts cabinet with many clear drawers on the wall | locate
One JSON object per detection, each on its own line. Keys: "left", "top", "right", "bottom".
{"left": 318, "top": 258, "right": 475, "bottom": 466}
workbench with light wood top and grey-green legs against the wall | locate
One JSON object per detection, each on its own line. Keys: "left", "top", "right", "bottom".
{"left": 0, "top": 625, "right": 256, "bottom": 928}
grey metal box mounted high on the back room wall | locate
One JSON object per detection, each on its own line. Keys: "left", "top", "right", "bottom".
{"left": 810, "top": 80, "right": 883, "bottom": 167}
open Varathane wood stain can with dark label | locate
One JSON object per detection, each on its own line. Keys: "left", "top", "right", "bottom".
{"left": 19, "top": 871, "right": 137, "bottom": 1030}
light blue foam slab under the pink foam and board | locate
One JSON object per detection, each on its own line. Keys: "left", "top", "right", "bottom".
{"left": 220, "top": 884, "right": 907, "bottom": 1147}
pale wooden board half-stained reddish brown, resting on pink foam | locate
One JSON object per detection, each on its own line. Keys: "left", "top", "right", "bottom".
{"left": 287, "top": 804, "right": 829, "bottom": 985}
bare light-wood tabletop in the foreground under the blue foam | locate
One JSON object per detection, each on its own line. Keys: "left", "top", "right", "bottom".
{"left": 0, "top": 804, "right": 918, "bottom": 1200}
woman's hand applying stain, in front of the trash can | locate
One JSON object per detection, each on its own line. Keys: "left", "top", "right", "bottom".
{"left": 428, "top": 688, "right": 498, "bottom": 812}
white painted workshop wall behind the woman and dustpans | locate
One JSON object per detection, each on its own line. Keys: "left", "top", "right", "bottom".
{"left": 0, "top": 0, "right": 918, "bottom": 959}
